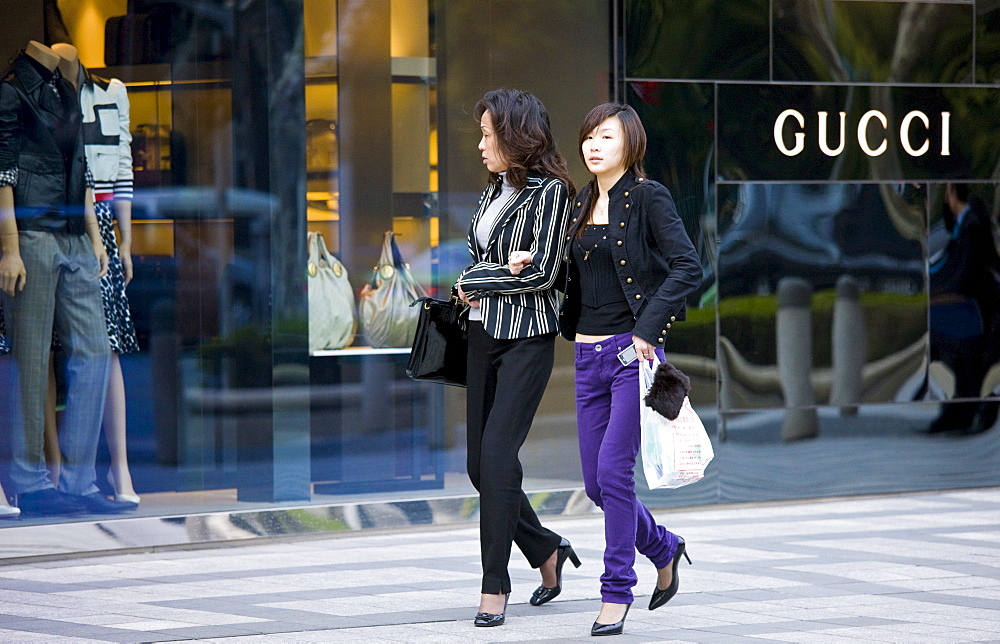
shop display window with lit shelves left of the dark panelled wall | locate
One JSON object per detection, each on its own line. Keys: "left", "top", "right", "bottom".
{"left": 0, "top": 0, "right": 610, "bottom": 531}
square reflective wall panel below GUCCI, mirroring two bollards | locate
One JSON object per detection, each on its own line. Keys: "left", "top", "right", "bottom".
{"left": 718, "top": 184, "right": 927, "bottom": 420}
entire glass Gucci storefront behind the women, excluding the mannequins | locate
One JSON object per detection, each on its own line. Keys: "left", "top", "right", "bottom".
{"left": 0, "top": 0, "right": 1000, "bottom": 557}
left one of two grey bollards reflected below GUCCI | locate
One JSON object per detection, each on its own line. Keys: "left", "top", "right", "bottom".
{"left": 775, "top": 277, "right": 819, "bottom": 441}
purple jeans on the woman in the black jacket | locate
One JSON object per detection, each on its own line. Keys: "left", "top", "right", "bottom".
{"left": 576, "top": 333, "right": 677, "bottom": 604}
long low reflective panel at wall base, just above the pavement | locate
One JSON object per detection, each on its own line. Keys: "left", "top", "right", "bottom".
{"left": 709, "top": 403, "right": 1000, "bottom": 503}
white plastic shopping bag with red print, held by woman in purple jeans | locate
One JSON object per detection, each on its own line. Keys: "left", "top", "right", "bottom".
{"left": 639, "top": 358, "right": 715, "bottom": 490}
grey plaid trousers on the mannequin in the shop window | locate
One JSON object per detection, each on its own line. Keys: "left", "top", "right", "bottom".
{"left": 3, "top": 231, "right": 111, "bottom": 495}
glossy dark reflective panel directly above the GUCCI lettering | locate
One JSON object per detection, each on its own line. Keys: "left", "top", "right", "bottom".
{"left": 773, "top": 0, "right": 974, "bottom": 83}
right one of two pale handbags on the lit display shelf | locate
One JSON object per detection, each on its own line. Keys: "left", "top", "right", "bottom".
{"left": 358, "top": 230, "right": 427, "bottom": 347}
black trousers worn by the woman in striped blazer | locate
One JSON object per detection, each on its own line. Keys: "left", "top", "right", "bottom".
{"left": 466, "top": 321, "right": 561, "bottom": 594}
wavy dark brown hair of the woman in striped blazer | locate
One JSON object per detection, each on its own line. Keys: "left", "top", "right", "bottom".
{"left": 475, "top": 88, "right": 576, "bottom": 199}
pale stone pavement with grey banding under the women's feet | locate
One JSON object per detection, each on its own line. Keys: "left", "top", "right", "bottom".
{"left": 0, "top": 488, "right": 1000, "bottom": 644}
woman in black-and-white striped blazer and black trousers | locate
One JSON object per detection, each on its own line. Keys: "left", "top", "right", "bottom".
{"left": 456, "top": 89, "right": 580, "bottom": 626}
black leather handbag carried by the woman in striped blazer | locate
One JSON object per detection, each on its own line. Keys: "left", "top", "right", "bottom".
{"left": 406, "top": 297, "right": 469, "bottom": 387}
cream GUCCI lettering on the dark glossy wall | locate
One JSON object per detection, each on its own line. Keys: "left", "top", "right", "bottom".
{"left": 774, "top": 110, "right": 951, "bottom": 157}
